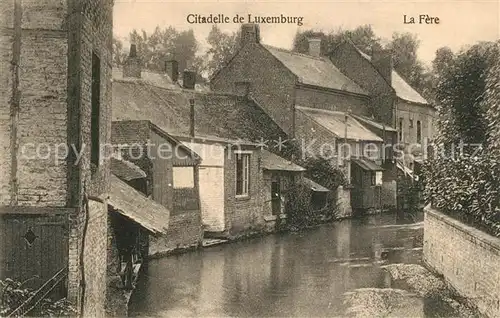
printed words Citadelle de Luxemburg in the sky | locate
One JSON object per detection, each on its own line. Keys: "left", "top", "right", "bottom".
{"left": 186, "top": 13, "right": 304, "bottom": 26}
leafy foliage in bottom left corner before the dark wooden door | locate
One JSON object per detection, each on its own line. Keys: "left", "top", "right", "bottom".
{"left": 0, "top": 278, "right": 77, "bottom": 317}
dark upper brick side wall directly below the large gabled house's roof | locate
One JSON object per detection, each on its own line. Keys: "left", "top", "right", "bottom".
{"left": 295, "top": 87, "right": 371, "bottom": 116}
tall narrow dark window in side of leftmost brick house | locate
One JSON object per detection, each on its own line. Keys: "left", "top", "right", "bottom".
{"left": 90, "top": 53, "right": 101, "bottom": 172}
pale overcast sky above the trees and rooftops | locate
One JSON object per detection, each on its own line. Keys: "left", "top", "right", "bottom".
{"left": 114, "top": 0, "right": 500, "bottom": 63}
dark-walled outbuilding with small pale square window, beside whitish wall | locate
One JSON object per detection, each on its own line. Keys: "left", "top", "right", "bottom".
{"left": 112, "top": 119, "right": 203, "bottom": 256}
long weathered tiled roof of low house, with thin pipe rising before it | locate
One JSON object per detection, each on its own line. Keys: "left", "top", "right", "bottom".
{"left": 112, "top": 73, "right": 286, "bottom": 141}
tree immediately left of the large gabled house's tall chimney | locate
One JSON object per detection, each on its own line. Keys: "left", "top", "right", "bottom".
{"left": 204, "top": 24, "right": 240, "bottom": 76}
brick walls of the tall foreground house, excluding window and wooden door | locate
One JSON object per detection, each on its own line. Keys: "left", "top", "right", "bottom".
{"left": 0, "top": 0, "right": 113, "bottom": 314}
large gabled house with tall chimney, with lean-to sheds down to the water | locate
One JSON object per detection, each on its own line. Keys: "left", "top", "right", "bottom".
{"left": 211, "top": 24, "right": 395, "bottom": 215}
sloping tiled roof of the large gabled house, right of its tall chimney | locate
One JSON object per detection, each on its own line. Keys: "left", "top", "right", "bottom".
{"left": 264, "top": 45, "right": 368, "bottom": 95}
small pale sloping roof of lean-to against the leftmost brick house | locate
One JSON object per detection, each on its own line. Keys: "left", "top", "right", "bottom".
{"left": 108, "top": 174, "right": 170, "bottom": 234}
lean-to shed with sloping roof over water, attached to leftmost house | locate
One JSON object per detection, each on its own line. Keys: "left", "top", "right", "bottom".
{"left": 105, "top": 163, "right": 170, "bottom": 317}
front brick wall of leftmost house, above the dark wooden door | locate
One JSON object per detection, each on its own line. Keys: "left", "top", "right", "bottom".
{"left": 0, "top": 1, "right": 68, "bottom": 206}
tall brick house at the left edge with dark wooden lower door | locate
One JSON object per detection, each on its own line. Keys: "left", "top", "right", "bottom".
{"left": 0, "top": 0, "right": 113, "bottom": 316}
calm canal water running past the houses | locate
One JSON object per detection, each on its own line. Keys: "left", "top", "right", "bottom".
{"left": 129, "top": 214, "right": 458, "bottom": 317}
